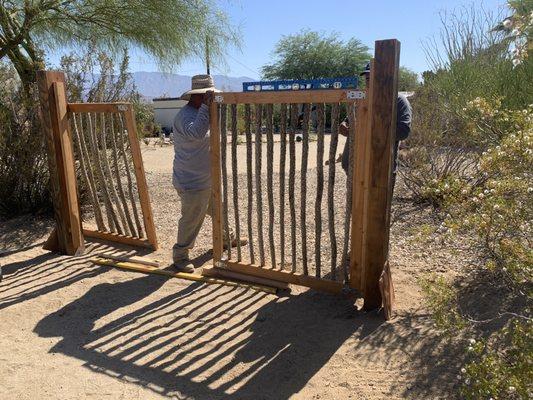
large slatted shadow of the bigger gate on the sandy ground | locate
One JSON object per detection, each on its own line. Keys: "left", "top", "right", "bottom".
{"left": 30, "top": 268, "right": 462, "bottom": 399}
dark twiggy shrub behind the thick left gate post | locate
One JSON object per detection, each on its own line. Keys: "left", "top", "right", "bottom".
{"left": 0, "top": 47, "right": 155, "bottom": 217}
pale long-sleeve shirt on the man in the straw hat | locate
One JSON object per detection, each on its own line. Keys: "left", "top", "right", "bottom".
{"left": 172, "top": 104, "right": 211, "bottom": 190}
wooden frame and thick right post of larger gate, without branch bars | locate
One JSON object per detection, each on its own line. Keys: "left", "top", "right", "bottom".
{"left": 210, "top": 39, "right": 400, "bottom": 313}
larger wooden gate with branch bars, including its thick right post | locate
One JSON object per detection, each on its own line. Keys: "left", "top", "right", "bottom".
{"left": 210, "top": 40, "right": 400, "bottom": 309}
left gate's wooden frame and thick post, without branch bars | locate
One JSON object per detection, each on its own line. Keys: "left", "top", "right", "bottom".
{"left": 37, "top": 71, "right": 158, "bottom": 255}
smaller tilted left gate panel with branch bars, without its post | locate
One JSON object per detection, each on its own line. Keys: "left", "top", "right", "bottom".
{"left": 68, "top": 103, "right": 157, "bottom": 249}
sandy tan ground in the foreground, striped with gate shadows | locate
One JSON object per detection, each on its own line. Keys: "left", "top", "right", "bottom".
{"left": 0, "top": 139, "right": 466, "bottom": 399}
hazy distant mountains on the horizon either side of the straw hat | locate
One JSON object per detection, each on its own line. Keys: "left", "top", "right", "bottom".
{"left": 132, "top": 71, "right": 255, "bottom": 100}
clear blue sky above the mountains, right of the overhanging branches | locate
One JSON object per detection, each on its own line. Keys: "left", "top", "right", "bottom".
{"left": 51, "top": 0, "right": 506, "bottom": 78}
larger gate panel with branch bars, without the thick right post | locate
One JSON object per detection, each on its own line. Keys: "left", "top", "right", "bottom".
{"left": 211, "top": 90, "right": 364, "bottom": 293}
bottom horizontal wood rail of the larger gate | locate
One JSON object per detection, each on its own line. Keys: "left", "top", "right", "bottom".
{"left": 224, "top": 261, "right": 344, "bottom": 294}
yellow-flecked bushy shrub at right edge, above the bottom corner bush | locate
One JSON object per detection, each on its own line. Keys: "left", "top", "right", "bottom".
{"left": 447, "top": 98, "right": 533, "bottom": 285}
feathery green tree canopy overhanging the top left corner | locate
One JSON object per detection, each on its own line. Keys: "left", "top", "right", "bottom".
{"left": 0, "top": 0, "right": 237, "bottom": 87}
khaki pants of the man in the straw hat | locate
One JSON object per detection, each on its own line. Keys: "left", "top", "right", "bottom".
{"left": 172, "top": 189, "right": 233, "bottom": 262}
